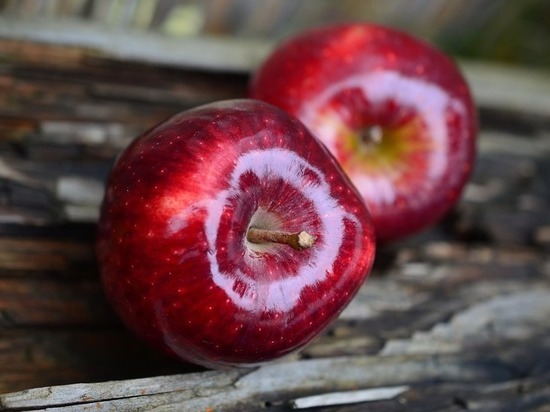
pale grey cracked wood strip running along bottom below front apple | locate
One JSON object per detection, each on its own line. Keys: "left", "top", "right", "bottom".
{"left": 1, "top": 355, "right": 532, "bottom": 411}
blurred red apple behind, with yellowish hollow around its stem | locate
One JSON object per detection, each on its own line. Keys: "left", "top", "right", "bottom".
{"left": 250, "top": 23, "right": 477, "bottom": 241}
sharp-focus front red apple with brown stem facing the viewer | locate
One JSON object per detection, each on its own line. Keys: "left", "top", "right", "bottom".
{"left": 97, "top": 99, "right": 375, "bottom": 367}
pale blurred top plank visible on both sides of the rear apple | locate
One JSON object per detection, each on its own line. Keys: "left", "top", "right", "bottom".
{"left": 0, "top": 17, "right": 550, "bottom": 117}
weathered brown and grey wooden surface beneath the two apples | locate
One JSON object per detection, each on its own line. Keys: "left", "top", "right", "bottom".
{"left": 0, "top": 36, "right": 550, "bottom": 411}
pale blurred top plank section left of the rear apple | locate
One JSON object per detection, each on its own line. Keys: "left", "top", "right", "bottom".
{"left": 0, "top": 17, "right": 270, "bottom": 73}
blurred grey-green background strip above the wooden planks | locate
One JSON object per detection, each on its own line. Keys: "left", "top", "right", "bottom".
{"left": 0, "top": 0, "right": 550, "bottom": 69}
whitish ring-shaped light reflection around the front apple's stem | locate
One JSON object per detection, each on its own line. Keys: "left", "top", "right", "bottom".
{"left": 205, "top": 149, "right": 356, "bottom": 310}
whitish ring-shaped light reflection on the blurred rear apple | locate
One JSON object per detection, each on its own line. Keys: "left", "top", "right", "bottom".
{"left": 294, "top": 71, "right": 470, "bottom": 227}
